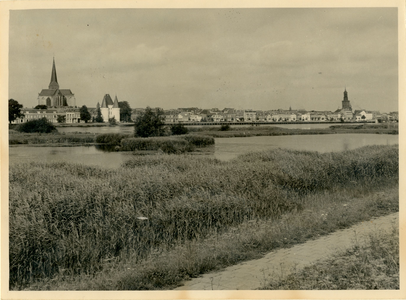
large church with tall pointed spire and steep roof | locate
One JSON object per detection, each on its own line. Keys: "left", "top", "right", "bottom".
{"left": 38, "top": 59, "right": 76, "bottom": 108}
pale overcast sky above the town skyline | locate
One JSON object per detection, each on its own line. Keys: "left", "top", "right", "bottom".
{"left": 9, "top": 8, "right": 398, "bottom": 112}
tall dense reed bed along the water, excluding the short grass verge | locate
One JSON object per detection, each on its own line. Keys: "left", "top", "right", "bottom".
{"left": 9, "top": 146, "right": 398, "bottom": 289}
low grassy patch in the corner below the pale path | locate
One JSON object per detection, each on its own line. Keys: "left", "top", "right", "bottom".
{"left": 263, "top": 228, "right": 399, "bottom": 290}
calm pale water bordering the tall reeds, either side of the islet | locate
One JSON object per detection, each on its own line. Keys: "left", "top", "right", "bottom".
{"left": 9, "top": 134, "right": 398, "bottom": 168}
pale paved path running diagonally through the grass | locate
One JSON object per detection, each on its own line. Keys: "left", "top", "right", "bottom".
{"left": 176, "top": 213, "right": 399, "bottom": 290}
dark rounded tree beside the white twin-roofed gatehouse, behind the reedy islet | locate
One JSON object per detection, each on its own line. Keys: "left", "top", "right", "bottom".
{"left": 134, "top": 107, "right": 165, "bottom": 137}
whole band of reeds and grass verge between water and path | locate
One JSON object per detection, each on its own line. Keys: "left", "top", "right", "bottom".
{"left": 10, "top": 146, "right": 398, "bottom": 290}
